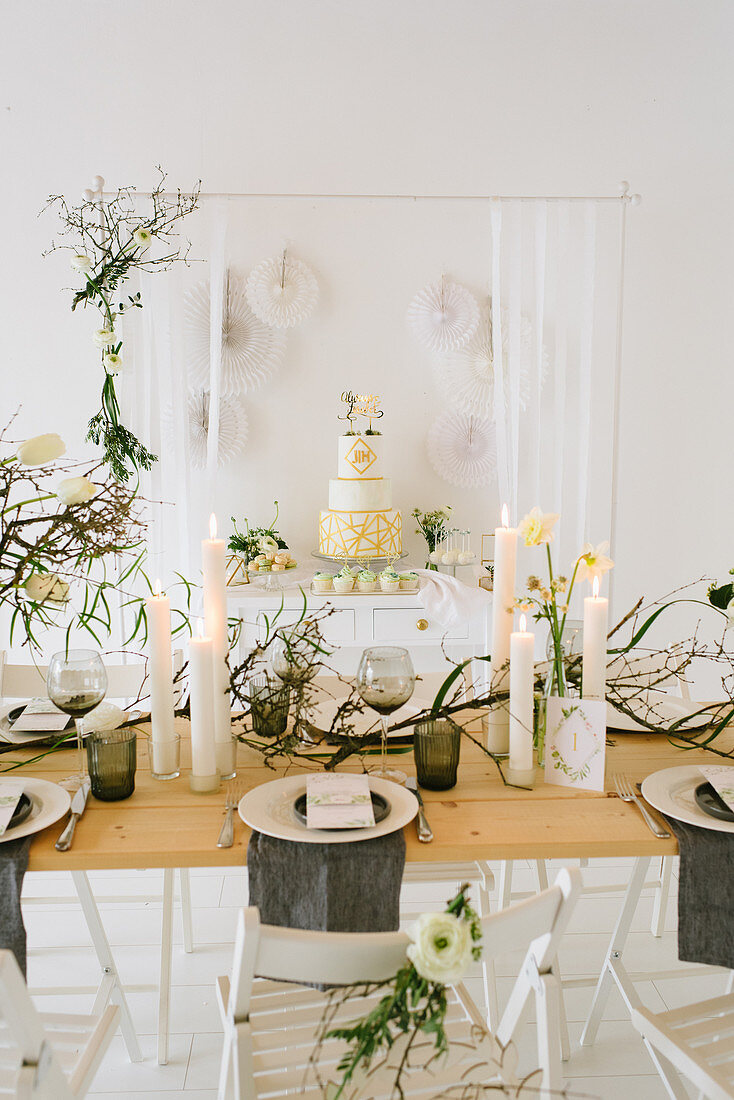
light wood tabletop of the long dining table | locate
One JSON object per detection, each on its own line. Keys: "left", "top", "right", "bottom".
{"left": 8, "top": 722, "right": 734, "bottom": 871}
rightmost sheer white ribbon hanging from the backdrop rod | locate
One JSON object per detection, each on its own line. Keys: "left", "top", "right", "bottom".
{"left": 577, "top": 201, "right": 596, "bottom": 547}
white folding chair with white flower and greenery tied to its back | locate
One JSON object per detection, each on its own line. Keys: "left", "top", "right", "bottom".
{"left": 217, "top": 870, "right": 581, "bottom": 1100}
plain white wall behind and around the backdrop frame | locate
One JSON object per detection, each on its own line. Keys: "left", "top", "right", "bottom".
{"left": 0, "top": 0, "right": 734, "bottom": 638}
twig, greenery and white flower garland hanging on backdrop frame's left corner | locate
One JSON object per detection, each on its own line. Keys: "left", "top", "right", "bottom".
{"left": 44, "top": 167, "right": 200, "bottom": 481}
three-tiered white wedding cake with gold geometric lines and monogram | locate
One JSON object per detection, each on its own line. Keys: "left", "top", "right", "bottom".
{"left": 319, "top": 435, "right": 403, "bottom": 559}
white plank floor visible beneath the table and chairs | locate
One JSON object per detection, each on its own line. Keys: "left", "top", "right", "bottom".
{"left": 25, "top": 860, "right": 726, "bottom": 1100}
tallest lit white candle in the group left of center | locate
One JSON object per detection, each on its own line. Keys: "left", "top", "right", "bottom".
{"left": 201, "top": 514, "right": 234, "bottom": 779}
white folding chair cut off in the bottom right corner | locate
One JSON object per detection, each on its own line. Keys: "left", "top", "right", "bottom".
{"left": 632, "top": 993, "right": 734, "bottom": 1100}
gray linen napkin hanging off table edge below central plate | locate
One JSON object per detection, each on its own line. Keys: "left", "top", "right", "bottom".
{"left": 248, "top": 829, "right": 405, "bottom": 932}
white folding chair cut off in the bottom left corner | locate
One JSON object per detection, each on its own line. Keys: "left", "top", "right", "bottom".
{"left": 0, "top": 950, "right": 119, "bottom": 1100}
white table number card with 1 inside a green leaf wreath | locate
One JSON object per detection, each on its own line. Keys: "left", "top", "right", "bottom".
{"left": 546, "top": 696, "right": 606, "bottom": 791}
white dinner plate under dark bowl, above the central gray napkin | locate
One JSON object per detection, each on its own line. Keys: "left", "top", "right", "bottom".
{"left": 238, "top": 776, "right": 418, "bottom": 844}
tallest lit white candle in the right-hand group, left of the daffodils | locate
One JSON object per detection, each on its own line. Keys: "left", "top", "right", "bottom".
{"left": 486, "top": 504, "right": 517, "bottom": 756}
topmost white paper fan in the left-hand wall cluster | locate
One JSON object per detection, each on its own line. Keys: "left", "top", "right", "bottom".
{"left": 247, "top": 252, "right": 318, "bottom": 329}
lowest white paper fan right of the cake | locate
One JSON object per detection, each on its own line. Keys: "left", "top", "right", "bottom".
{"left": 428, "top": 410, "right": 497, "bottom": 488}
